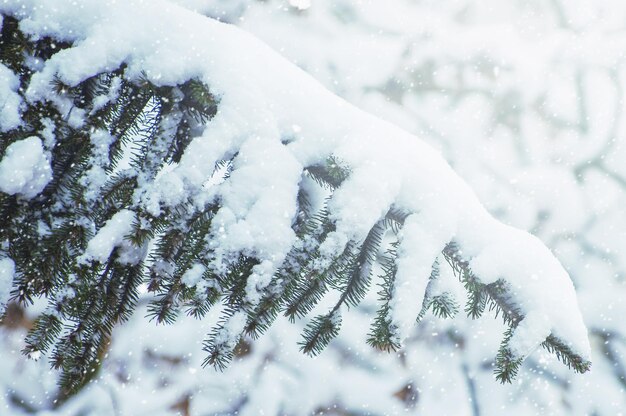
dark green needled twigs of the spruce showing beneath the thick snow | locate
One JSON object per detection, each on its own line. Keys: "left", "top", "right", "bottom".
{"left": 0, "top": 4, "right": 590, "bottom": 400}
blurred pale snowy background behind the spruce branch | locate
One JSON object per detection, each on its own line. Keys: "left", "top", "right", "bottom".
{"left": 0, "top": 0, "right": 626, "bottom": 416}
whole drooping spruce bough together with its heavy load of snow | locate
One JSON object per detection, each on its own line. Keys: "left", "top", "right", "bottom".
{"left": 0, "top": 0, "right": 590, "bottom": 390}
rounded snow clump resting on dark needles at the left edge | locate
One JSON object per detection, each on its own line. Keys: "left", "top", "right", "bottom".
{"left": 0, "top": 136, "right": 52, "bottom": 198}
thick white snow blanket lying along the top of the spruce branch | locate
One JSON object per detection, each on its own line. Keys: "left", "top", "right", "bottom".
{"left": 0, "top": 0, "right": 590, "bottom": 358}
